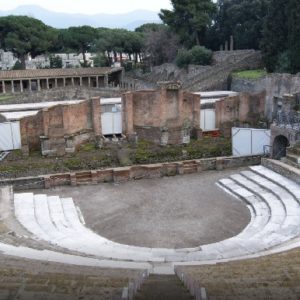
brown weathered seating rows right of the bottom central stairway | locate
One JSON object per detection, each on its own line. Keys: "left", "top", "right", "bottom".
{"left": 180, "top": 248, "right": 300, "bottom": 300}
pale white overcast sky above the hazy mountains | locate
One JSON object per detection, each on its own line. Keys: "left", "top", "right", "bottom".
{"left": 0, "top": 0, "right": 171, "bottom": 14}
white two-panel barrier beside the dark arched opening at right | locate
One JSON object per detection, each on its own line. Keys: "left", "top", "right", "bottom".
{"left": 232, "top": 127, "right": 271, "bottom": 156}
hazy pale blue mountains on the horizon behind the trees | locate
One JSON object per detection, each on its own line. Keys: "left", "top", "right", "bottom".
{"left": 0, "top": 5, "right": 161, "bottom": 30}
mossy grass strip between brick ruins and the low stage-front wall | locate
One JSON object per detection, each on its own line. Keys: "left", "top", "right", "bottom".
{"left": 0, "top": 137, "right": 231, "bottom": 179}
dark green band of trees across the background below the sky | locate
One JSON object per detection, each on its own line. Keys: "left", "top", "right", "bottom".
{"left": 0, "top": 0, "right": 300, "bottom": 73}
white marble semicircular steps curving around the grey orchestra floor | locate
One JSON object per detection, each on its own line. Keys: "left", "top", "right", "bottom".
{"left": 4, "top": 166, "right": 300, "bottom": 268}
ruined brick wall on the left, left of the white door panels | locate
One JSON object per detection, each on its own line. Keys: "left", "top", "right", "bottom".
{"left": 20, "top": 98, "right": 101, "bottom": 155}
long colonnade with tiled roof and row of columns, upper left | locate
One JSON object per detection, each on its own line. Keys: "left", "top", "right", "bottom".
{"left": 0, "top": 68, "right": 123, "bottom": 94}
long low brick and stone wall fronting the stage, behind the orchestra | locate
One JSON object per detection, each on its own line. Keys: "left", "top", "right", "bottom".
{"left": 0, "top": 156, "right": 261, "bottom": 190}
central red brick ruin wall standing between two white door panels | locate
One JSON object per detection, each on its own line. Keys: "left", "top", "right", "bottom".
{"left": 122, "top": 83, "right": 200, "bottom": 144}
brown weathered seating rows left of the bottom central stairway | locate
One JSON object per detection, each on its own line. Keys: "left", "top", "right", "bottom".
{"left": 0, "top": 266, "right": 135, "bottom": 300}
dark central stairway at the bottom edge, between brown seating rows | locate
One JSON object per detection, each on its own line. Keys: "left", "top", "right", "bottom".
{"left": 135, "top": 275, "right": 194, "bottom": 300}
